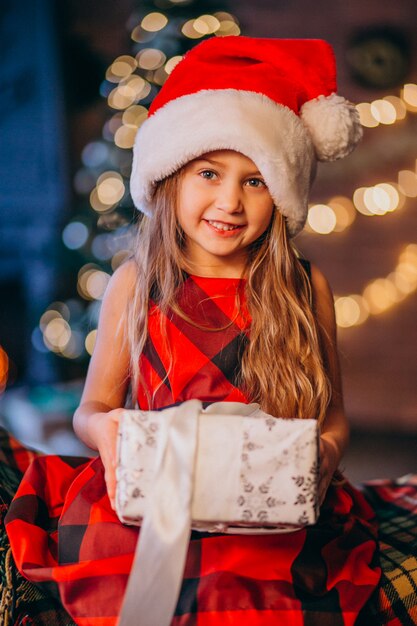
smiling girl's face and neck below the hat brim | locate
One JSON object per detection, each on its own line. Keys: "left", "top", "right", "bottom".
{"left": 177, "top": 150, "right": 274, "bottom": 277}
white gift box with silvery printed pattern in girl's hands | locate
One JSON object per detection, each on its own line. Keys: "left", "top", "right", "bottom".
{"left": 116, "top": 400, "right": 318, "bottom": 533}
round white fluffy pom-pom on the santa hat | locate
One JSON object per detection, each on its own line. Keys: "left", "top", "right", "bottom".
{"left": 301, "top": 93, "right": 362, "bottom": 161}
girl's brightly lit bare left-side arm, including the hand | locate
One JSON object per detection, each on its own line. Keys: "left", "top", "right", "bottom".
{"left": 73, "top": 261, "right": 136, "bottom": 504}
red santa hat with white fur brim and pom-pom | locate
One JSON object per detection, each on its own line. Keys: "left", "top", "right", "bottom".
{"left": 131, "top": 36, "right": 362, "bottom": 236}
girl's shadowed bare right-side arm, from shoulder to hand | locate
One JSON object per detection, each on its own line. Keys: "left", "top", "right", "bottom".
{"left": 311, "top": 265, "right": 349, "bottom": 504}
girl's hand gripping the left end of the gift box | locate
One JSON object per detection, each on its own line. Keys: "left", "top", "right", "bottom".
{"left": 88, "top": 409, "right": 124, "bottom": 510}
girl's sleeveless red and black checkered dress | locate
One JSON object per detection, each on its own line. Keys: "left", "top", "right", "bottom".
{"left": 6, "top": 276, "right": 380, "bottom": 626}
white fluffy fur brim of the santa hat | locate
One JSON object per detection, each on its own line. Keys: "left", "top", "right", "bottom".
{"left": 130, "top": 89, "right": 316, "bottom": 235}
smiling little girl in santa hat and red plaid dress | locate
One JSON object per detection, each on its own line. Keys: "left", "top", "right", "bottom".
{"left": 7, "top": 37, "right": 379, "bottom": 626}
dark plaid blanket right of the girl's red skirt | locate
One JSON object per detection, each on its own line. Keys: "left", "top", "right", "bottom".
{"left": 363, "top": 475, "right": 417, "bottom": 626}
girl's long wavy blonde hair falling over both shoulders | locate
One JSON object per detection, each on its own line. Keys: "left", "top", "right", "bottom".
{"left": 128, "top": 171, "right": 331, "bottom": 422}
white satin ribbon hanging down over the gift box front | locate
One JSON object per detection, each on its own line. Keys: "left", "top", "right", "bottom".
{"left": 118, "top": 400, "right": 202, "bottom": 626}
